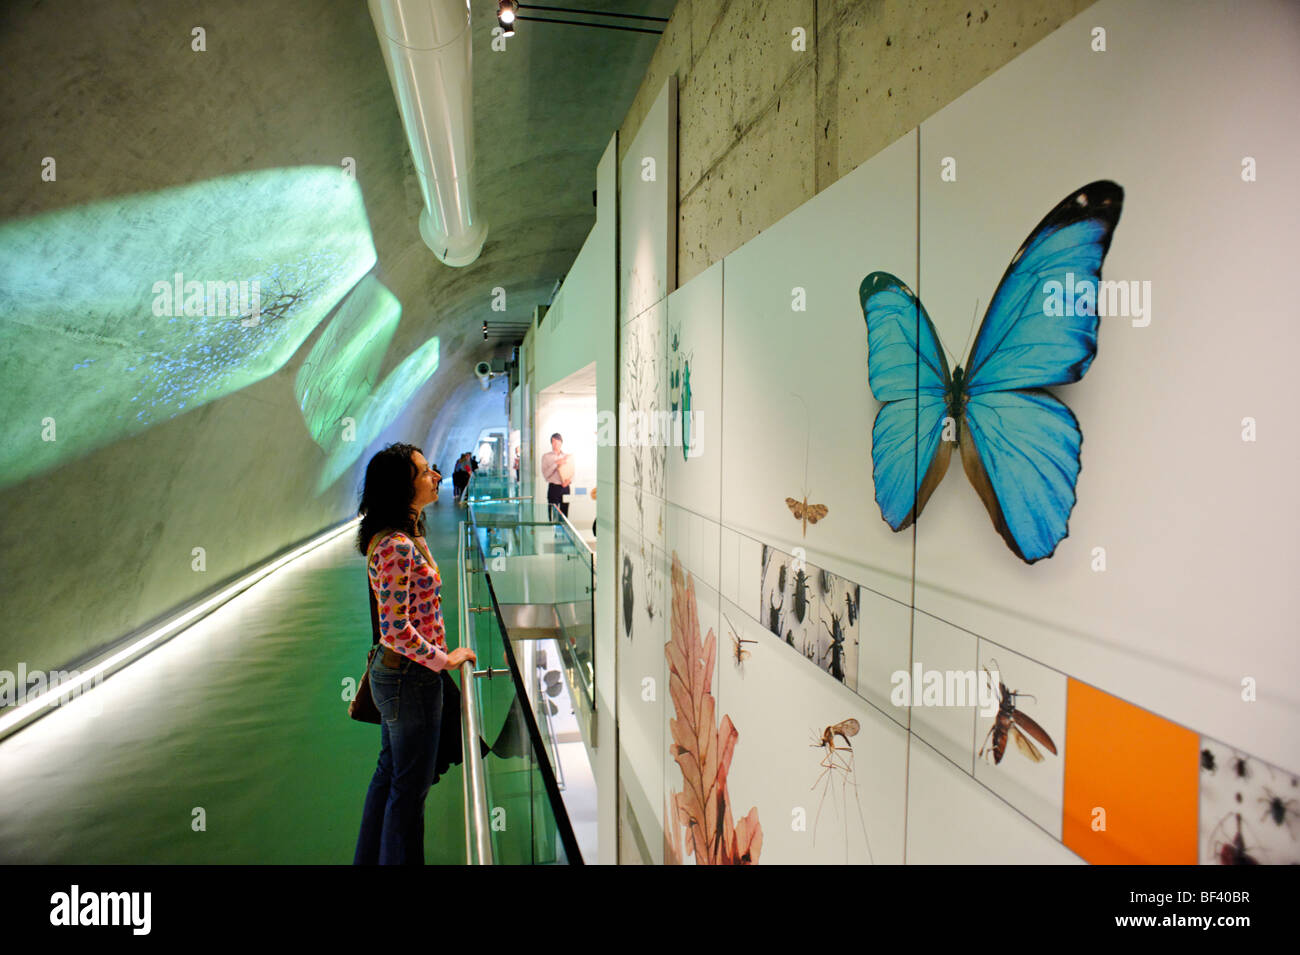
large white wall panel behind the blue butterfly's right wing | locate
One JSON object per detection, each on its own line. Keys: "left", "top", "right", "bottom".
{"left": 909, "top": 0, "right": 1300, "bottom": 764}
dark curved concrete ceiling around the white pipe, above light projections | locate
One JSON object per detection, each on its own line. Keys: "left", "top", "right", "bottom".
{"left": 0, "top": 0, "right": 673, "bottom": 452}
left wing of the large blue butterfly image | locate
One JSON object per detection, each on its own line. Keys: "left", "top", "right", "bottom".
{"left": 858, "top": 272, "right": 952, "bottom": 530}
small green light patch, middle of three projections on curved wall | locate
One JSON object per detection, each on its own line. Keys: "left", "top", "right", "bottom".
{"left": 294, "top": 275, "right": 402, "bottom": 451}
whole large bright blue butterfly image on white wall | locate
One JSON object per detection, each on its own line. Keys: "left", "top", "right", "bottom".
{"left": 858, "top": 181, "right": 1125, "bottom": 564}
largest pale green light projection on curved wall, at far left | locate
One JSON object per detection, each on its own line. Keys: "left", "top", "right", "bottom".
{"left": 0, "top": 168, "right": 376, "bottom": 486}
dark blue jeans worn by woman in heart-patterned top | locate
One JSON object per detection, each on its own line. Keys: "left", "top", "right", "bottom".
{"left": 352, "top": 648, "right": 442, "bottom": 865}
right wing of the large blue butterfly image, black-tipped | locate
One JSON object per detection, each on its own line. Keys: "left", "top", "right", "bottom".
{"left": 961, "top": 181, "right": 1123, "bottom": 564}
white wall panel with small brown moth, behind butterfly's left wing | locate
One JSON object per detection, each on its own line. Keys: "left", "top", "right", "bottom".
{"left": 722, "top": 134, "right": 917, "bottom": 600}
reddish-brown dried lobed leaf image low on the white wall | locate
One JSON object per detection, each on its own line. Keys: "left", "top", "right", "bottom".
{"left": 664, "top": 554, "right": 763, "bottom": 865}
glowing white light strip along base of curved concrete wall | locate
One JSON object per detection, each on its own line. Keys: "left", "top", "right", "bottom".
{"left": 0, "top": 517, "right": 360, "bottom": 741}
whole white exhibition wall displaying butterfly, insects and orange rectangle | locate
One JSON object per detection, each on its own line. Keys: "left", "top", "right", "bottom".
{"left": 620, "top": 0, "right": 1300, "bottom": 863}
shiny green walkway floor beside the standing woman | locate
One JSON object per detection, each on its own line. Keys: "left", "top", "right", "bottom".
{"left": 0, "top": 495, "right": 464, "bottom": 864}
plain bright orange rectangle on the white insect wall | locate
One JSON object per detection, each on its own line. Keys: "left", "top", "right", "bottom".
{"left": 1061, "top": 680, "right": 1200, "bottom": 865}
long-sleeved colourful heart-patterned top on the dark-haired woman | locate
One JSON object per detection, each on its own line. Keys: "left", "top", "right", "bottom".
{"left": 365, "top": 531, "right": 447, "bottom": 672}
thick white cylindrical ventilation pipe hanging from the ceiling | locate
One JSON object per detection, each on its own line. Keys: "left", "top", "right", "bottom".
{"left": 369, "top": 0, "right": 488, "bottom": 265}
